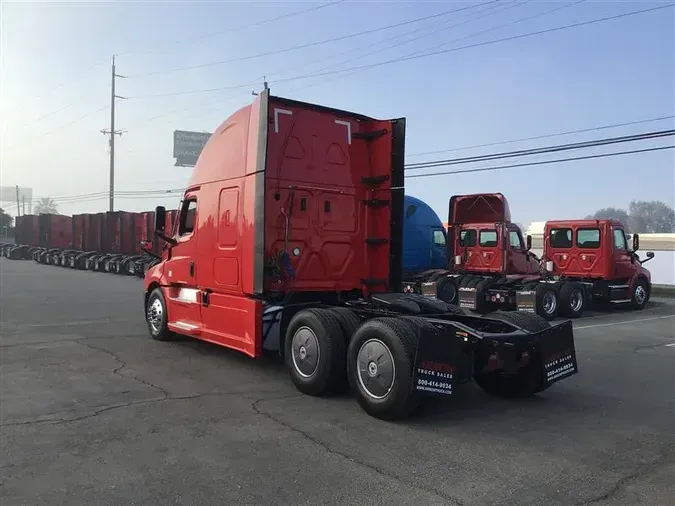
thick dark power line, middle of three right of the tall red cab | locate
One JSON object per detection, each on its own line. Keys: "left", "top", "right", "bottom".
{"left": 405, "top": 130, "right": 675, "bottom": 170}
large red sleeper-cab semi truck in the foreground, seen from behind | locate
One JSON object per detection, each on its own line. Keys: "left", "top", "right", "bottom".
{"left": 144, "top": 90, "right": 578, "bottom": 419}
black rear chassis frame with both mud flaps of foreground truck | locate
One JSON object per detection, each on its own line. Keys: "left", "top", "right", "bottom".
{"left": 265, "top": 293, "right": 578, "bottom": 397}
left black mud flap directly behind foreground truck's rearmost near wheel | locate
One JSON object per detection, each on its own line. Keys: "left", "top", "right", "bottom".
{"left": 412, "top": 328, "right": 473, "bottom": 396}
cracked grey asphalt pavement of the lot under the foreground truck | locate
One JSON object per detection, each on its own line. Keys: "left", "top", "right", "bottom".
{"left": 0, "top": 258, "right": 675, "bottom": 506}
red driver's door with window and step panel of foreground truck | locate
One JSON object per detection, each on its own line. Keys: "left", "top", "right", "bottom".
{"left": 164, "top": 197, "right": 202, "bottom": 336}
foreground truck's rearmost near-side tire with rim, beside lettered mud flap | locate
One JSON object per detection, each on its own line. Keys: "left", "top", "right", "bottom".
{"left": 347, "top": 318, "right": 421, "bottom": 420}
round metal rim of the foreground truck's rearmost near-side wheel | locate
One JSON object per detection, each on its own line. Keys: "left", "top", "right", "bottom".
{"left": 356, "top": 339, "right": 396, "bottom": 399}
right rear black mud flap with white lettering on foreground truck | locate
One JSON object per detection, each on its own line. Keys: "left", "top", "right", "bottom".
{"left": 537, "top": 321, "right": 579, "bottom": 386}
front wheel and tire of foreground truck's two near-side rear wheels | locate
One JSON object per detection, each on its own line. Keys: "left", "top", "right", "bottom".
{"left": 284, "top": 309, "right": 347, "bottom": 396}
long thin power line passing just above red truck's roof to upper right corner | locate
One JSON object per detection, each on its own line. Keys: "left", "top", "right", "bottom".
{"left": 131, "top": 4, "right": 675, "bottom": 98}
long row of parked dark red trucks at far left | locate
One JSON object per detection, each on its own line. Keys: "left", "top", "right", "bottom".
{"left": 0, "top": 211, "right": 177, "bottom": 277}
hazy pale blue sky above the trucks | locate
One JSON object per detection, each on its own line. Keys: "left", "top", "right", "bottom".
{"left": 0, "top": 0, "right": 675, "bottom": 224}
